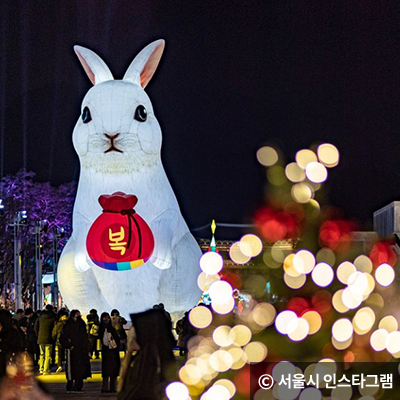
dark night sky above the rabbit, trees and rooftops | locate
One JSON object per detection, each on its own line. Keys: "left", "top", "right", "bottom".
{"left": 0, "top": 0, "right": 400, "bottom": 234}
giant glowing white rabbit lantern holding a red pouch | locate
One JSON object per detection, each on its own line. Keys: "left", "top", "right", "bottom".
{"left": 58, "top": 40, "right": 201, "bottom": 315}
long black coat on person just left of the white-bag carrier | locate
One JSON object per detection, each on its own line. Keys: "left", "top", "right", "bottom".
{"left": 60, "top": 318, "right": 92, "bottom": 381}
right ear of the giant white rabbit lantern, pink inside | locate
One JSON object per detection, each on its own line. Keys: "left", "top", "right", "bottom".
{"left": 123, "top": 39, "right": 165, "bottom": 89}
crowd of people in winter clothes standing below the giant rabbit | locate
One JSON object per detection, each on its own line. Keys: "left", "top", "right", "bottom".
{"left": 0, "top": 304, "right": 196, "bottom": 400}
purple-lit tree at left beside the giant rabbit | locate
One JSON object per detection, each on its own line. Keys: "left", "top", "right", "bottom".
{"left": 0, "top": 170, "right": 76, "bottom": 306}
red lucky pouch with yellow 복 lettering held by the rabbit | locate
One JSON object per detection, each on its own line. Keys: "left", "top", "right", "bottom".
{"left": 86, "top": 192, "right": 154, "bottom": 271}
